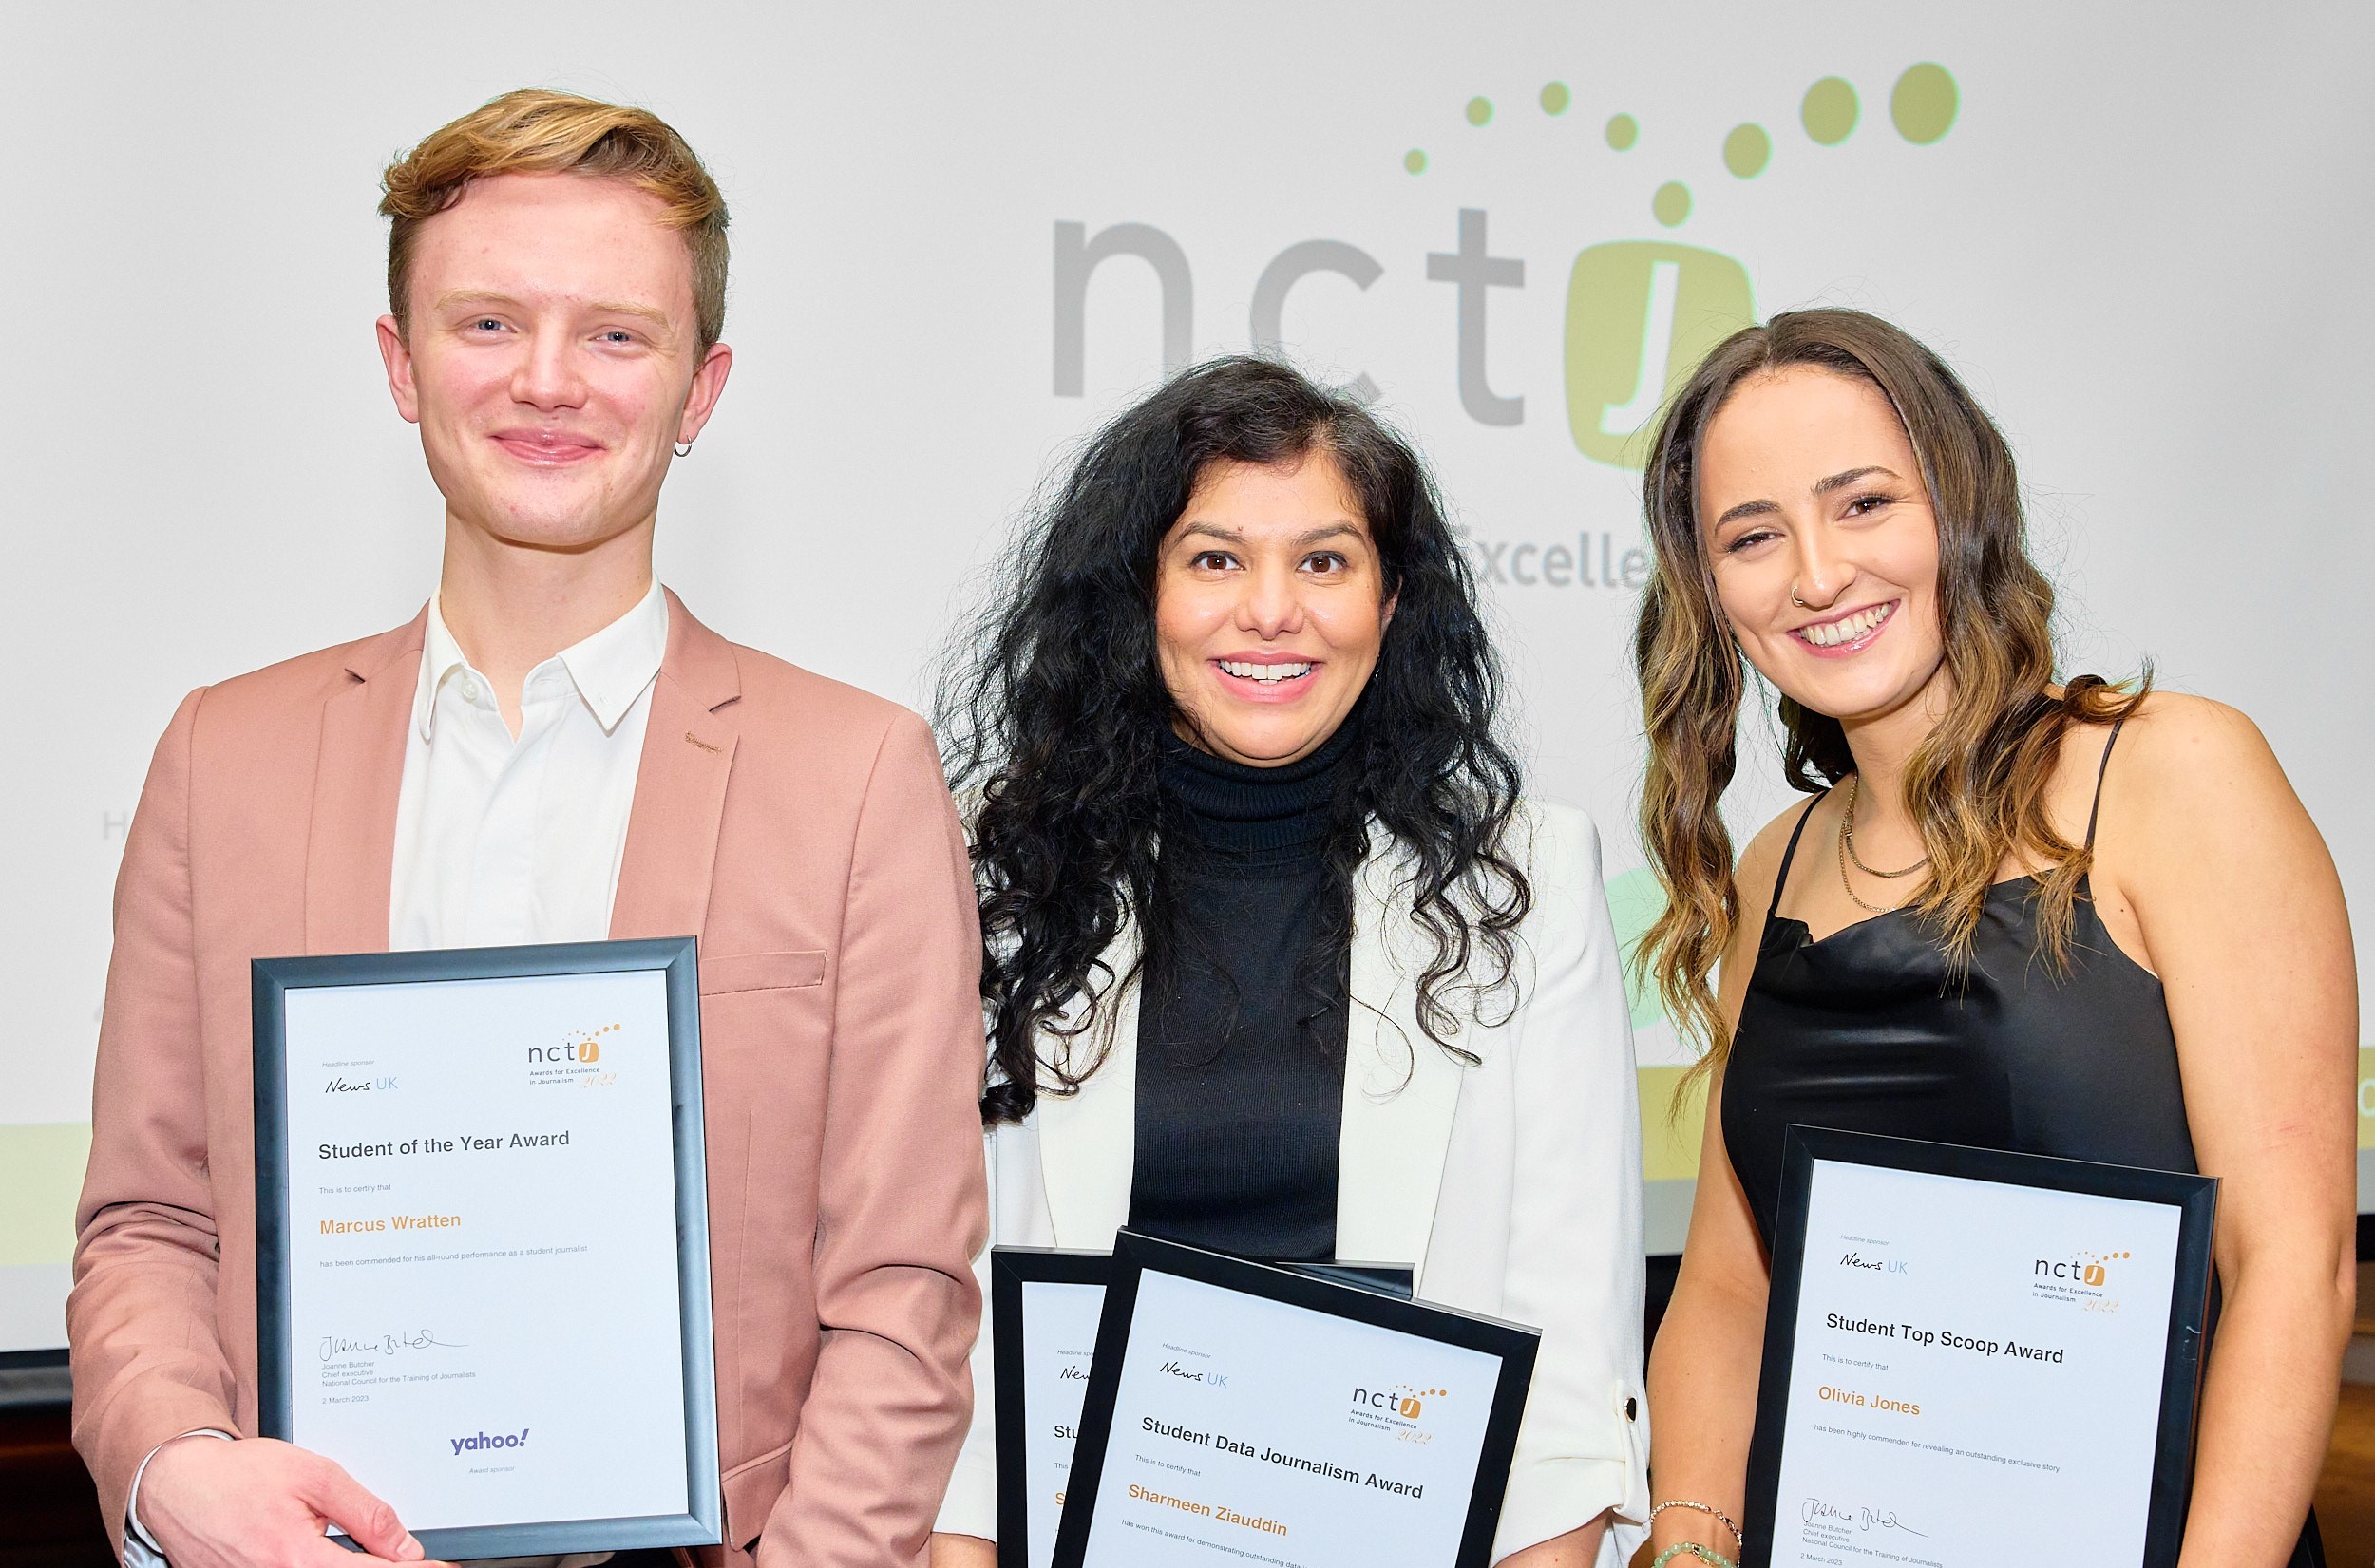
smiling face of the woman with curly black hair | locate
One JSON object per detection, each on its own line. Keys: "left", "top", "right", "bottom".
{"left": 1154, "top": 451, "right": 1395, "bottom": 767}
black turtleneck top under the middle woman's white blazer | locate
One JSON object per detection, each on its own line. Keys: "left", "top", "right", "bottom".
{"left": 1130, "top": 722, "right": 1358, "bottom": 1261}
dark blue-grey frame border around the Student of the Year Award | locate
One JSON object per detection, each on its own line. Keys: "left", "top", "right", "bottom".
{"left": 250, "top": 936, "right": 725, "bottom": 1560}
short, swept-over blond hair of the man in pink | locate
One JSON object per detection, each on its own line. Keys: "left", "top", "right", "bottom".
{"left": 380, "top": 88, "right": 727, "bottom": 351}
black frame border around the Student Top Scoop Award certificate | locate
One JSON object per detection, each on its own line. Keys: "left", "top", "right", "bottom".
{"left": 1741, "top": 1124, "right": 2218, "bottom": 1568}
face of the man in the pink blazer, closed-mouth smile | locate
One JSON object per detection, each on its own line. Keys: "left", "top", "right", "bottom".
{"left": 366, "top": 174, "right": 734, "bottom": 551}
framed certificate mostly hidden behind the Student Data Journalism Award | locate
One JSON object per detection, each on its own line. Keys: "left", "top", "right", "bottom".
{"left": 991, "top": 1247, "right": 1411, "bottom": 1568}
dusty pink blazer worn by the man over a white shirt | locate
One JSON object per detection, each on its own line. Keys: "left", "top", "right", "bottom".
{"left": 66, "top": 594, "right": 986, "bottom": 1568}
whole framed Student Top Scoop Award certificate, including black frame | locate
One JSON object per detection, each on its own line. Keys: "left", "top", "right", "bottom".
{"left": 1743, "top": 1126, "right": 2218, "bottom": 1568}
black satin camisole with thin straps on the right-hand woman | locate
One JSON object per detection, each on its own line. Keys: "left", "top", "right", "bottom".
{"left": 1724, "top": 725, "right": 2326, "bottom": 1568}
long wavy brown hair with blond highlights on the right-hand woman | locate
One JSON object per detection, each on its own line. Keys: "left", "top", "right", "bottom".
{"left": 1634, "top": 309, "right": 2152, "bottom": 1062}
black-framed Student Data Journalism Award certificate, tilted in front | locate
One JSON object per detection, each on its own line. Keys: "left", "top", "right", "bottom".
{"left": 1054, "top": 1231, "right": 1539, "bottom": 1568}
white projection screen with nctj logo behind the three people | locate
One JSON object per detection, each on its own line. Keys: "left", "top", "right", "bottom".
{"left": 0, "top": 0, "right": 2375, "bottom": 1351}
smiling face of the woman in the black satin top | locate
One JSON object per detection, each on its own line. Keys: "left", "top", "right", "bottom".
{"left": 1699, "top": 366, "right": 1946, "bottom": 729}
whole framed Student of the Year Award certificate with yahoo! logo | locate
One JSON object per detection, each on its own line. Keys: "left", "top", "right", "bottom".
{"left": 255, "top": 936, "right": 722, "bottom": 1559}
